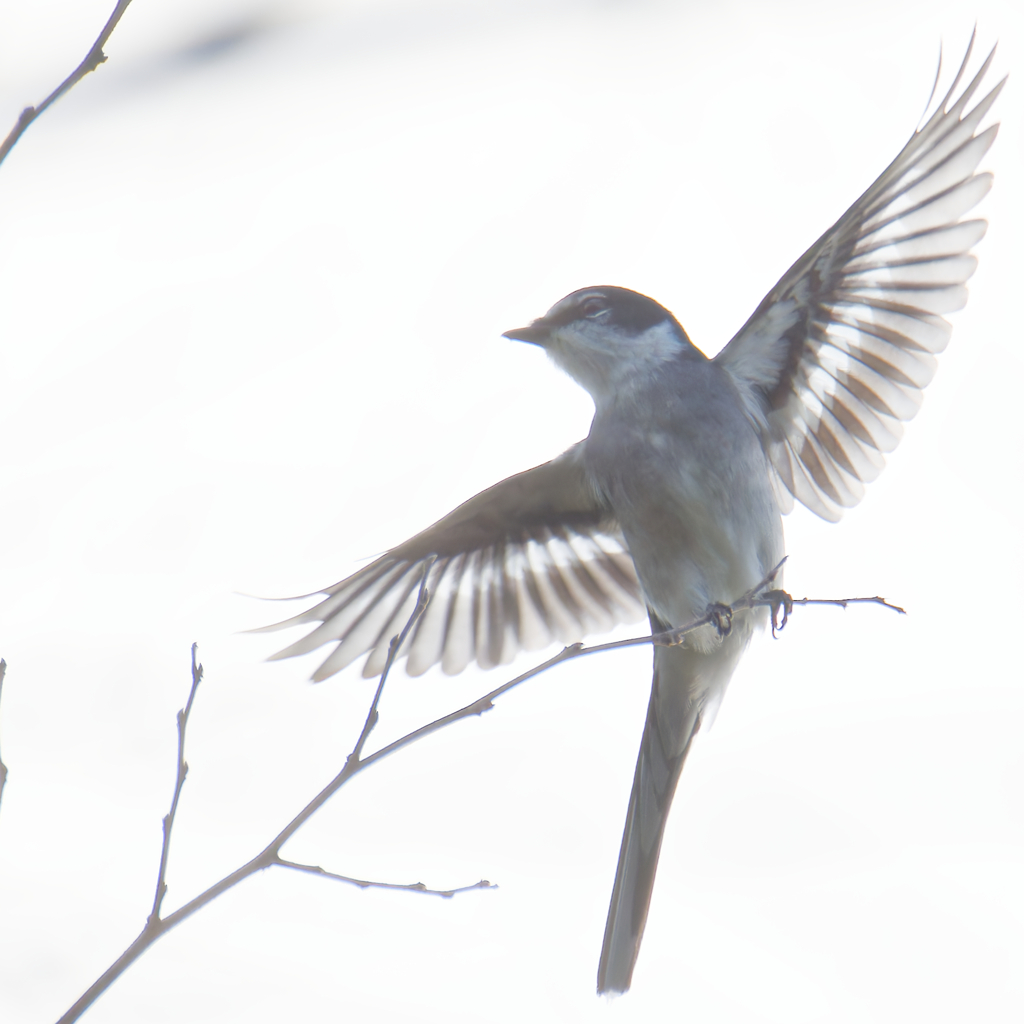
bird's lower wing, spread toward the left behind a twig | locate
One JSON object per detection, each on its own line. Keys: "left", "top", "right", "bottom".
{"left": 255, "top": 442, "right": 645, "bottom": 681}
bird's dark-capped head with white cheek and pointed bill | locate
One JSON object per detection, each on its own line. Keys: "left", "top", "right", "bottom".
{"left": 504, "top": 286, "right": 696, "bottom": 399}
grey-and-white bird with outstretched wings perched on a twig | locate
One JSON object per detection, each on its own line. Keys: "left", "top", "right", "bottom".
{"left": 253, "top": 36, "right": 1006, "bottom": 993}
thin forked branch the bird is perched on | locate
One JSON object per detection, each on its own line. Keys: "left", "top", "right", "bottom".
{"left": 57, "top": 559, "right": 904, "bottom": 1024}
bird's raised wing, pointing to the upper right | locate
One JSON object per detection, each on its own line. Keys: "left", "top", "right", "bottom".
{"left": 716, "top": 37, "right": 1006, "bottom": 521}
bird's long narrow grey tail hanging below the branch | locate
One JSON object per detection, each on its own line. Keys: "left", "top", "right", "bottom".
{"left": 597, "top": 615, "right": 707, "bottom": 993}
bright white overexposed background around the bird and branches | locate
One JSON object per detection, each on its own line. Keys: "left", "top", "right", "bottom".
{"left": 0, "top": 0, "right": 1024, "bottom": 1024}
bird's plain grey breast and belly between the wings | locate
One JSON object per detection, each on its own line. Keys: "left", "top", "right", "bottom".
{"left": 586, "top": 359, "right": 782, "bottom": 624}
